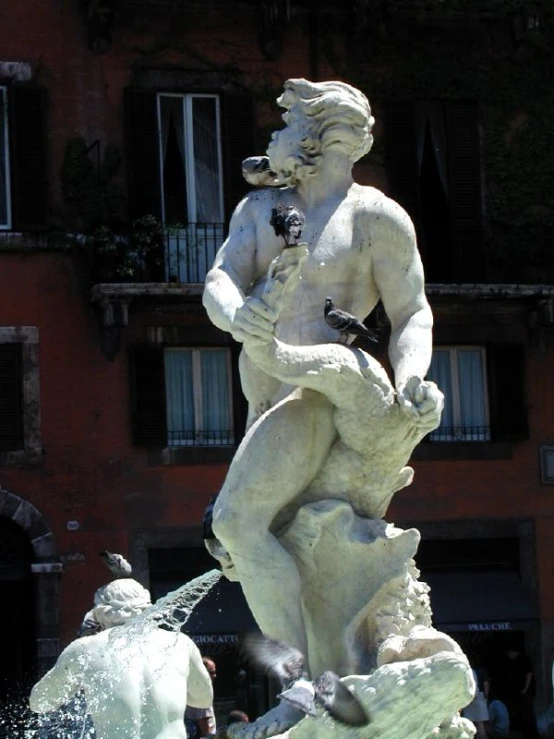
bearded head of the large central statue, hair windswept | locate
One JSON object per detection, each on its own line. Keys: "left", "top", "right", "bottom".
{"left": 267, "top": 79, "right": 375, "bottom": 184}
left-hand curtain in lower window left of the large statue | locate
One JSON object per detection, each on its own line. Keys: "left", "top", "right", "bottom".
{"left": 165, "top": 349, "right": 194, "bottom": 445}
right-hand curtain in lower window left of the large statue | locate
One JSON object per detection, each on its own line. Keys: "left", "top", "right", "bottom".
{"left": 201, "top": 349, "right": 232, "bottom": 444}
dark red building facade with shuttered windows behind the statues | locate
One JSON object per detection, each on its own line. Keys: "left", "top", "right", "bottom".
{"left": 0, "top": 0, "right": 554, "bottom": 724}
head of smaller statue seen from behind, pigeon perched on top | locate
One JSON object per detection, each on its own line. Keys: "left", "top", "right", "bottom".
{"left": 92, "top": 577, "right": 152, "bottom": 629}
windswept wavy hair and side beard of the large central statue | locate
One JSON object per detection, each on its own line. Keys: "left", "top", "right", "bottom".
{"left": 270, "top": 78, "right": 375, "bottom": 185}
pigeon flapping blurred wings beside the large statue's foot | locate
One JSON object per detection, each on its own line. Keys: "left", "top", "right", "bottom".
{"left": 241, "top": 634, "right": 370, "bottom": 726}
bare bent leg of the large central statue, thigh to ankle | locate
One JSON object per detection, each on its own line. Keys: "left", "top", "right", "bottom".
{"left": 213, "top": 391, "right": 336, "bottom": 652}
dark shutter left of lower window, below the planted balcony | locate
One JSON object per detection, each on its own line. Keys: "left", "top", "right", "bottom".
{"left": 131, "top": 346, "right": 167, "bottom": 446}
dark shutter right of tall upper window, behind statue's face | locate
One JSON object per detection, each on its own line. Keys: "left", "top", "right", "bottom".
{"left": 222, "top": 93, "right": 257, "bottom": 219}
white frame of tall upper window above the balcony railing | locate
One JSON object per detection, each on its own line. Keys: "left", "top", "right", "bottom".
{"left": 156, "top": 92, "right": 224, "bottom": 225}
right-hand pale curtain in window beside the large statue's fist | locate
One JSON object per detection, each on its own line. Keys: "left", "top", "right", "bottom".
{"left": 457, "top": 349, "right": 487, "bottom": 439}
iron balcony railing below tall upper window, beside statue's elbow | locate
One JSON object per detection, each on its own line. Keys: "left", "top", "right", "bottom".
{"left": 164, "top": 223, "right": 225, "bottom": 283}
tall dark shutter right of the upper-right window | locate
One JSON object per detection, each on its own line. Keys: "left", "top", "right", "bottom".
{"left": 445, "top": 102, "right": 483, "bottom": 282}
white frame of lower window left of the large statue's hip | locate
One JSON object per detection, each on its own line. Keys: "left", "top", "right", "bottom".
{"left": 164, "top": 346, "right": 235, "bottom": 448}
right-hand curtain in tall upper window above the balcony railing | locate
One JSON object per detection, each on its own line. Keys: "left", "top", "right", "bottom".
{"left": 192, "top": 97, "right": 223, "bottom": 223}
